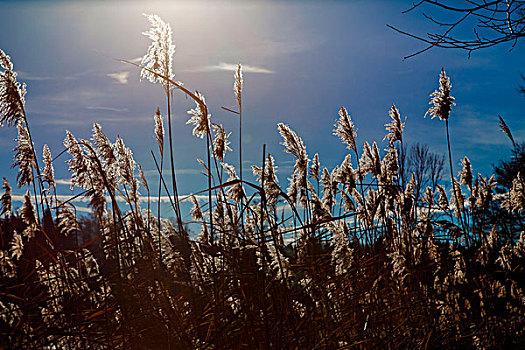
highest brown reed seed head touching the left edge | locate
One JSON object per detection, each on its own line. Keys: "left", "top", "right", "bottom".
{"left": 0, "top": 50, "right": 26, "bottom": 126}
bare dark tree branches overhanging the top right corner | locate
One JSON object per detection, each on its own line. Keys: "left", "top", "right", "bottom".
{"left": 388, "top": 0, "right": 525, "bottom": 59}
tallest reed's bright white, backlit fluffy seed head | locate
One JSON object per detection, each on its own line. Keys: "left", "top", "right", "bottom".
{"left": 140, "top": 14, "right": 175, "bottom": 86}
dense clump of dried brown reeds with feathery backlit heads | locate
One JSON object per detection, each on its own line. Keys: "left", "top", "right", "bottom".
{"left": 0, "top": 15, "right": 525, "bottom": 349}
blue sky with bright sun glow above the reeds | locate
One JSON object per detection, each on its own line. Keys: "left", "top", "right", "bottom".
{"left": 0, "top": 1, "right": 525, "bottom": 215}
